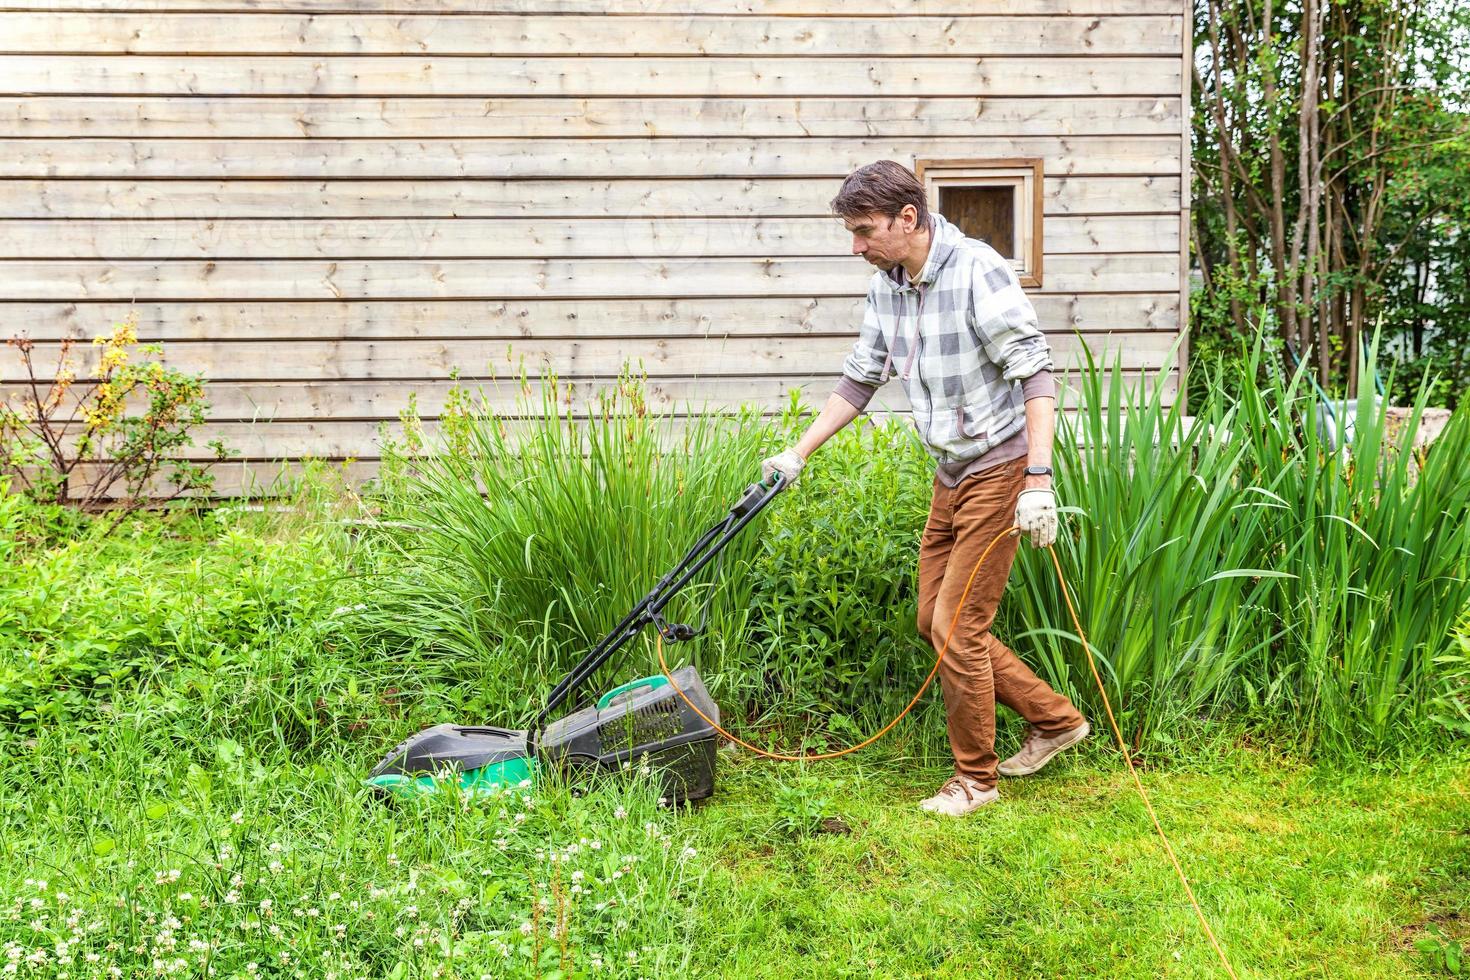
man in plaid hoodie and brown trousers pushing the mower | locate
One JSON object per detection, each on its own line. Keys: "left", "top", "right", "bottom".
{"left": 761, "top": 160, "right": 1089, "bottom": 817}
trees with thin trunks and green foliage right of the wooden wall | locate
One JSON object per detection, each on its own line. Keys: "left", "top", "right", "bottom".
{"left": 1191, "top": 0, "right": 1470, "bottom": 401}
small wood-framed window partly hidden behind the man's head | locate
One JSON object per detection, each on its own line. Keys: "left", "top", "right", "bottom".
{"left": 914, "top": 159, "right": 1042, "bottom": 288}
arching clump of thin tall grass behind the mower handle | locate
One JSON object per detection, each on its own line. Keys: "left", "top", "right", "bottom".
{"left": 362, "top": 376, "right": 772, "bottom": 728}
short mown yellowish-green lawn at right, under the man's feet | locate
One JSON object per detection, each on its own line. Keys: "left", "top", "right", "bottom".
{"left": 694, "top": 740, "right": 1470, "bottom": 977}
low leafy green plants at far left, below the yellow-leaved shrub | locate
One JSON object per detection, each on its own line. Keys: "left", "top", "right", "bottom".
{"left": 0, "top": 495, "right": 348, "bottom": 729}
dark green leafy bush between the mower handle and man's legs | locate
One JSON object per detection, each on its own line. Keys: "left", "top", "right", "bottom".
{"left": 745, "top": 402, "right": 933, "bottom": 736}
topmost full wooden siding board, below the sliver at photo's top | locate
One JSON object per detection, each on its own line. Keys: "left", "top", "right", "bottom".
{"left": 0, "top": 12, "right": 1183, "bottom": 57}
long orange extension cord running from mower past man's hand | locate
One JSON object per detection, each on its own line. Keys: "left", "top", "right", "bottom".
{"left": 654, "top": 527, "right": 1238, "bottom": 980}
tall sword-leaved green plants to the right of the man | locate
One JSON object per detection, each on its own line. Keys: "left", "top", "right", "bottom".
{"left": 1008, "top": 333, "right": 1470, "bottom": 752}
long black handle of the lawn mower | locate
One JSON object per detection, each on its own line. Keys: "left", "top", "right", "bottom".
{"left": 526, "top": 472, "right": 788, "bottom": 751}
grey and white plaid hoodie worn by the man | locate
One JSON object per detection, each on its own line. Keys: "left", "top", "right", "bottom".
{"left": 836, "top": 213, "right": 1051, "bottom": 466}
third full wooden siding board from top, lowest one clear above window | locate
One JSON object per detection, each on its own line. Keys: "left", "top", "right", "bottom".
{"left": 0, "top": 96, "right": 1182, "bottom": 140}
